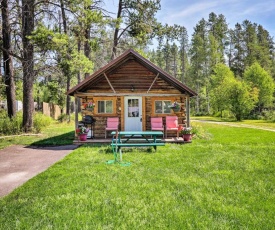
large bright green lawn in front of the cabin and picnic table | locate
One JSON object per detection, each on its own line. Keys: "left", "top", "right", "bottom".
{"left": 0, "top": 121, "right": 275, "bottom": 229}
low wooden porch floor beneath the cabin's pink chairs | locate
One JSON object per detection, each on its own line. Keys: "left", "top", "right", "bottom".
{"left": 73, "top": 137, "right": 192, "bottom": 145}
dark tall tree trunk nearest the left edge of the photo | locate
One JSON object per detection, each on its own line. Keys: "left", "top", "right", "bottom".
{"left": 1, "top": 0, "right": 16, "bottom": 118}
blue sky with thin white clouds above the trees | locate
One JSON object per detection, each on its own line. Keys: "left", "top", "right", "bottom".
{"left": 104, "top": 0, "right": 275, "bottom": 39}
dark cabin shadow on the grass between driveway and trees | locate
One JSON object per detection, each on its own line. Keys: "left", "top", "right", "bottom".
{"left": 31, "top": 131, "right": 75, "bottom": 146}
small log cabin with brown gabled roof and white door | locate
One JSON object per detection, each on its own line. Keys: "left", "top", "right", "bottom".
{"left": 67, "top": 49, "right": 197, "bottom": 138}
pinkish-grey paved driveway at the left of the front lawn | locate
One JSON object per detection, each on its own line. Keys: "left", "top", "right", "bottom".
{"left": 0, "top": 145, "right": 78, "bottom": 197}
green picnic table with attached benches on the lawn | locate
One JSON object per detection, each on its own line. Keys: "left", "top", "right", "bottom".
{"left": 107, "top": 131, "right": 165, "bottom": 165}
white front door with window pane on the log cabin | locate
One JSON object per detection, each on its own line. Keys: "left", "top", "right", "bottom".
{"left": 124, "top": 97, "right": 142, "bottom": 131}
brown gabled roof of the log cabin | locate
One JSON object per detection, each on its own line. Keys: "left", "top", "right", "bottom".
{"left": 67, "top": 49, "right": 197, "bottom": 97}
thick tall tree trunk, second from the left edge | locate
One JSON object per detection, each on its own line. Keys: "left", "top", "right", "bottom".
{"left": 22, "top": 0, "right": 35, "bottom": 132}
